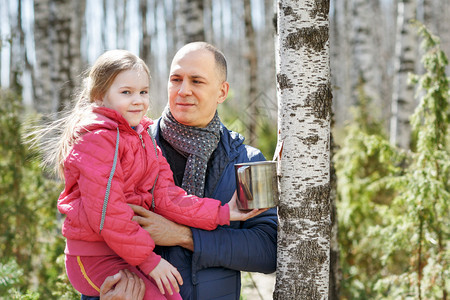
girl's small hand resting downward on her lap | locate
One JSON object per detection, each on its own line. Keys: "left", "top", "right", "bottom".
{"left": 149, "top": 258, "right": 183, "bottom": 295}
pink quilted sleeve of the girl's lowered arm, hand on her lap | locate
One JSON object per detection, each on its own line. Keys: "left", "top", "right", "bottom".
{"left": 65, "top": 130, "right": 161, "bottom": 274}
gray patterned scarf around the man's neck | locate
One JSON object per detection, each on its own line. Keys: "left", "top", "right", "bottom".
{"left": 160, "top": 106, "right": 220, "bottom": 197}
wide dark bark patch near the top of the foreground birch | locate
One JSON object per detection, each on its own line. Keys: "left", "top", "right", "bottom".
{"left": 284, "top": 26, "right": 328, "bottom": 52}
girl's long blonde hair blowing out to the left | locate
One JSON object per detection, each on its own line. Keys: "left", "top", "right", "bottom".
{"left": 35, "top": 50, "right": 150, "bottom": 178}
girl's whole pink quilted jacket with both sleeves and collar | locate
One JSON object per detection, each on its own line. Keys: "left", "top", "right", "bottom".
{"left": 58, "top": 108, "right": 230, "bottom": 274}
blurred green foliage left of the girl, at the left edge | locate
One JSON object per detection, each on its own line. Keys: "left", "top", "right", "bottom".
{"left": 0, "top": 90, "right": 79, "bottom": 299}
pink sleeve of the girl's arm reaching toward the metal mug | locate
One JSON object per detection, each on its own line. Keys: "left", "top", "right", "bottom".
{"left": 149, "top": 147, "right": 230, "bottom": 230}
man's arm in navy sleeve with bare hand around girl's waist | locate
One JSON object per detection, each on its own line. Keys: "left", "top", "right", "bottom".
{"left": 130, "top": 205, "right": 277, "bottom": 273}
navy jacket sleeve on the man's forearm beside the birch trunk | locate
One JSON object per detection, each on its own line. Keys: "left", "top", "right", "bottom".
{"left": 192, "top": 208, "right": 277, "bottom": 273}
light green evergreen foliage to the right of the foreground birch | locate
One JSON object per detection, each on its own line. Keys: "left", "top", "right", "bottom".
{"left": 335, "top": 25, "right": 450, "bottom": 299}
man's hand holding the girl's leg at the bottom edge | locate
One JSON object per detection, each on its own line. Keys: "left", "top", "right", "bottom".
{"left": 100, "top": 269, "right": 145, "bottom": 300}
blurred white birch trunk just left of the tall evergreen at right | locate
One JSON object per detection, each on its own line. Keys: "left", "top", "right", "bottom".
{"left": 390, "top": 0, "right": 418, "bottom": 149}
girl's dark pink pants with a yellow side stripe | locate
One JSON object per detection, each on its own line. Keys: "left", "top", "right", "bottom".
{"left": 66, "top": 255, "right": 181, "bottom": 300}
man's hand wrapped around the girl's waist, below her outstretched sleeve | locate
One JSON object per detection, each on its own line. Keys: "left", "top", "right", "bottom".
{"left": 128, "top": 204, "right": 194, "bottom": 251}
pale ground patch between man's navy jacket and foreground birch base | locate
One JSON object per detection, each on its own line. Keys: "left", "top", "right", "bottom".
{"left": 241, "top": 272, "right": 275, "bottom": 300}
